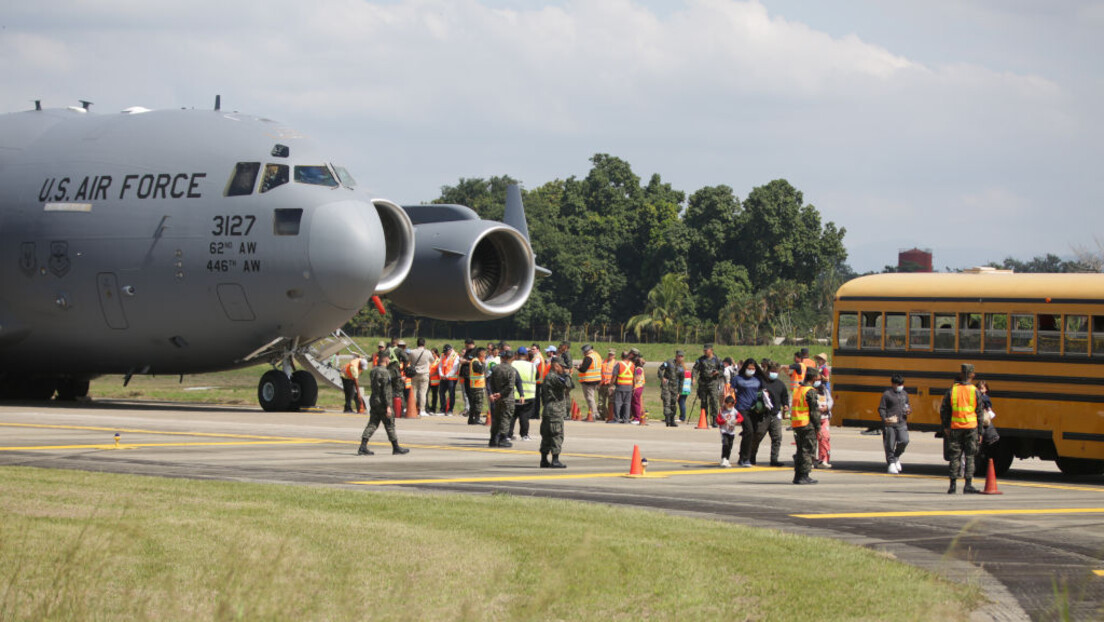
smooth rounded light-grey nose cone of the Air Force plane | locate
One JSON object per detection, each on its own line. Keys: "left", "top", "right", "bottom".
{"left": 309, "top": 201, "right": 384, "bottom": 310}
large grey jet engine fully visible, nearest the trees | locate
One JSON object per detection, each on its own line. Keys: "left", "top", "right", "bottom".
{"left": 391, "top": 205, "right": 535, "bottom": 321}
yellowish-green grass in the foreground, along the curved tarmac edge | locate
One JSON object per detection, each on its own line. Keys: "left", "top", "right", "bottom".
{"left": 0, "top": 467, "right": 980, "bottom": 621}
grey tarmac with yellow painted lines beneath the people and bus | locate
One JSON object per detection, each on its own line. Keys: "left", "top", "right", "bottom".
{"left": 0, "top": 401, "right": 1104, "bottom": 620}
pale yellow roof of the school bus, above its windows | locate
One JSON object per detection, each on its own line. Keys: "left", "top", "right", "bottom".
{"left": 836, "top": 272, "right": 1104, "bottom": 302}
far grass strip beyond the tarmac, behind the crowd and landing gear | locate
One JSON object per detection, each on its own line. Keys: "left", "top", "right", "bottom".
{"left": 91, "top": 338, "right": 816, "bottom": 423}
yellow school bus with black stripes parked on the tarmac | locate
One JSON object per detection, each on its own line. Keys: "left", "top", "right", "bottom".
{"left": 832, "top": 268, "right": 1104, "bottom": 475}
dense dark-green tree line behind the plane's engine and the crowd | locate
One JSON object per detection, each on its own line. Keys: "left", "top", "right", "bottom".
{"left": 346, "top": 154, "right": 854, "bottom": 342}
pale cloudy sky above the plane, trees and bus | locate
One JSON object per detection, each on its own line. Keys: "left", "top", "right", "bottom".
{"left": 0, "top": 0, "right": 1104, "bottom": 272}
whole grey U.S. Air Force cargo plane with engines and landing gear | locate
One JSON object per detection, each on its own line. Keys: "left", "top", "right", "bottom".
{"left": 0, "top": 99, "right": 541, "bottom": 411}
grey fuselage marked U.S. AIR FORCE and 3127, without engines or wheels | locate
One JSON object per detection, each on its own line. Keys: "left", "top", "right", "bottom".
{"left": 0, "top": 109, "right": 402, "bottom": 376}
